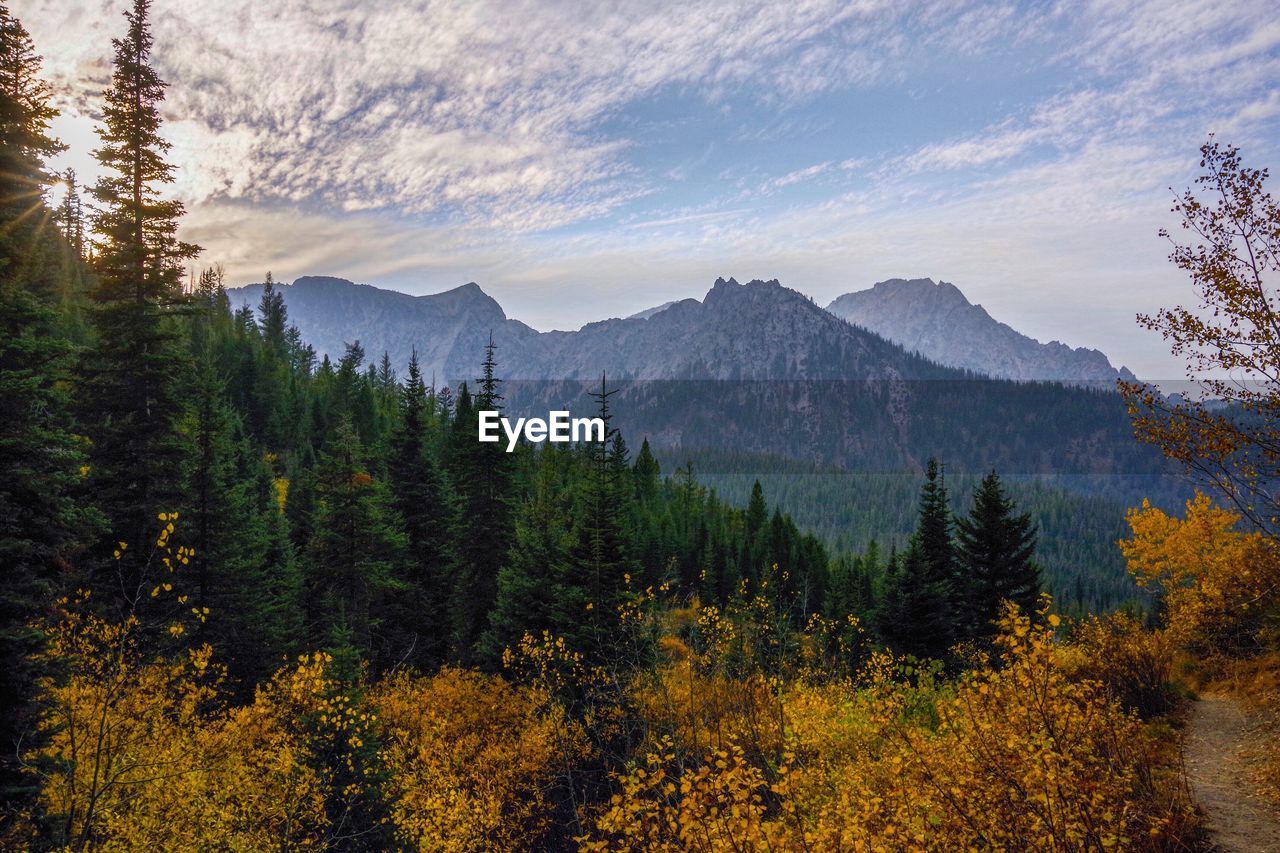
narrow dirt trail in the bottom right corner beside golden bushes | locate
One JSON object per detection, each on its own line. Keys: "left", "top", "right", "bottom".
{"left": 1185, "top": 694, "right": 1280, "bottom": 853}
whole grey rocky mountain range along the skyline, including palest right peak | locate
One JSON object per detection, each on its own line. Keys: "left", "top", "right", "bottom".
{"left": 228, "top": 277, "right": 1133, "bottom": 383}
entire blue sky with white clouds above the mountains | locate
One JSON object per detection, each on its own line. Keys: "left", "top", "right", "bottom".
{"left": 10, "top": 0, "right": 1280, "bottom": 379}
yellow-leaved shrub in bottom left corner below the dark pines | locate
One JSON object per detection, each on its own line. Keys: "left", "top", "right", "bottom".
{"left": 27, "top": 601, "right": 324, "bottom": 850}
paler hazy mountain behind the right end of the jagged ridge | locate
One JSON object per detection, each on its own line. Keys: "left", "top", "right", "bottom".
{"left": 827, "top": 278, "right": 1133, "bottom": 383}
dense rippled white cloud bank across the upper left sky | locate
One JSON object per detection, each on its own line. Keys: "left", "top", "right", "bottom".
{"left": 15, "top": 0, "right": 1039, "bottom": 219}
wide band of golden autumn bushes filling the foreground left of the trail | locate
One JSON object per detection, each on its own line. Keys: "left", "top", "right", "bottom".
{"left": 20, "top": 528, "right": 1216, "bottom": 850}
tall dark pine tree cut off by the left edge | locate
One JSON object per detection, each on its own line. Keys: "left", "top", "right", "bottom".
{"left": 0, "top": 5, "right": 93, "bottom": 811}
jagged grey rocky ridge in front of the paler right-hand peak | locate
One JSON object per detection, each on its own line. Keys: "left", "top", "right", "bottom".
{"left": 228, "top": 277, "right": 957, "bottom": 383}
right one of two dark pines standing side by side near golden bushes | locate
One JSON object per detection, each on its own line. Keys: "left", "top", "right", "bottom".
{"left": 956, "top": 471, "right": 1041, "bottom": 638}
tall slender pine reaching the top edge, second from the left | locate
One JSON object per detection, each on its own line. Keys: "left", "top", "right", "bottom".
{"left": 84, "top": 0, "right": 198, "bottom": 591}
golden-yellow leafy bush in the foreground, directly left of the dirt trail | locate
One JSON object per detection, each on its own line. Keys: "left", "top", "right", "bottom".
{"left": 584, "top": 604, "right": 1190, "bottom": 850}
